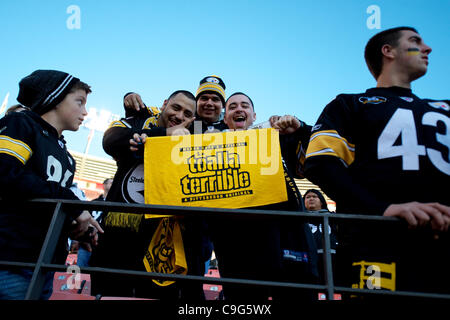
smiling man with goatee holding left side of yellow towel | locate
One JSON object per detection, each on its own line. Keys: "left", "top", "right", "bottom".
{"left": 91, "top": 90, "right": 204, "bottom": 299}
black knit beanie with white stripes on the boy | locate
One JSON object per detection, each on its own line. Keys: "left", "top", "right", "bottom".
{"left": 17, "top": 70, "right": 80, "bottom": 115}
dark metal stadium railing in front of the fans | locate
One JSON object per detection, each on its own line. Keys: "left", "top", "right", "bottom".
{"left": 0, "top": 199, "right": 450, "bottom": 300}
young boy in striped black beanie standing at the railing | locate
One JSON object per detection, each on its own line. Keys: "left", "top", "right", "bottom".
{"left": 0, "top": 70, "right": 103, "bottom": 299}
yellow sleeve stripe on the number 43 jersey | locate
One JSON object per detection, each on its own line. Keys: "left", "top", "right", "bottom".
{"left": 306, "top": 130, "right": 355, "bottom": 166}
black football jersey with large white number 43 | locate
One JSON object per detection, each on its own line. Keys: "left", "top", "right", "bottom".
{"left": 305, "top": 87, "right": 450, "bottom": 214}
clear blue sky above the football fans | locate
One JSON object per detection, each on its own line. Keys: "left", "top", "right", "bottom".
{"left": 0, "top": 0, "right": 450, "bottom": 157}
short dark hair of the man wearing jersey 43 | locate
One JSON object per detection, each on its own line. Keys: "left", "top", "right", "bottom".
{"left": 364, "top": 27, "right": 419, "bottom": 79}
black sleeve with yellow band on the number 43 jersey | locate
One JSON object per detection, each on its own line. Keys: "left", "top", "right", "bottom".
{"left": 305, "top": 95, "right": 389, "bottom": 215}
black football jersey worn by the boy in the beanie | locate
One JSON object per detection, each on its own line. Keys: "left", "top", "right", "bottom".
{"left": 0, "top": 111, "right": 81, "bottom": 261}
